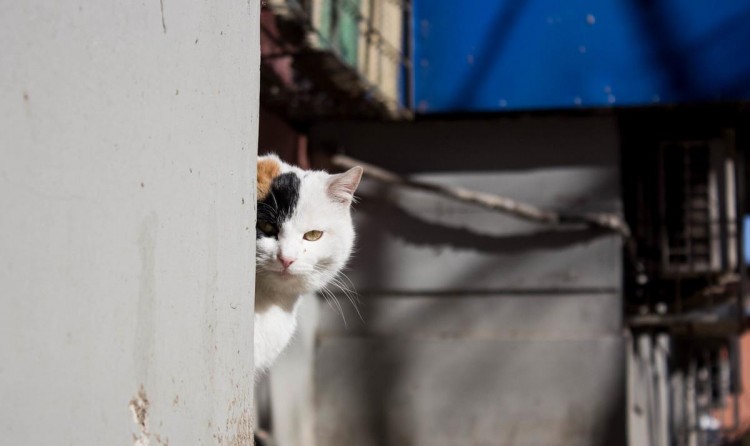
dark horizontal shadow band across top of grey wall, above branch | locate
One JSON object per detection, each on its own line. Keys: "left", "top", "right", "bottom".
{"left": 310, "top": 118, "right": 618, "bottom": 175}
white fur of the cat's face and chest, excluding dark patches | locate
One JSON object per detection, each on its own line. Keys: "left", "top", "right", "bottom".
{"left": 255, "top": 157, "right": 362, "bottom": 372}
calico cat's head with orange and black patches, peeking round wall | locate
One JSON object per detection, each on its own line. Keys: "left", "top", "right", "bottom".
{"left": 256, "top": 155, "right": 362, "bottom": 294}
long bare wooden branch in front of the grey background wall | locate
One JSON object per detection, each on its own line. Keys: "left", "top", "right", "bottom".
{"left": 331, "top": 155, "right": 630, "bottom": 238}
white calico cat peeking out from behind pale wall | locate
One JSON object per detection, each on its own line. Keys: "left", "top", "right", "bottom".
{"left": 254, "top": 155, "right": 362, "bottom": 378}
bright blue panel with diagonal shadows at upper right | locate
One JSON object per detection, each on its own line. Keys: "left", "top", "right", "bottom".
{"left": 413, "top": 0, "right": 750, "bottom": 113}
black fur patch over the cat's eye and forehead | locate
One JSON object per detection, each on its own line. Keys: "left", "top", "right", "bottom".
{"left": 255, "top": 172, "right": 300, "bottom": 239}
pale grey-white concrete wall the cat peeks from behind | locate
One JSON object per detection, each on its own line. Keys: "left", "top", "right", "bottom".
{"left": 0, "top": 0, "right": 260, "bottom": 445}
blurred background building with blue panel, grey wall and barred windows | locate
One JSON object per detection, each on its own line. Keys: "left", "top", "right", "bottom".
{"left": 259, "top": 0, "right": 750, "bottom": 446}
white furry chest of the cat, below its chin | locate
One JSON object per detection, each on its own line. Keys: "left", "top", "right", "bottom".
{"left": 254, "top": 306, "right": 297, "bottom": 369}
